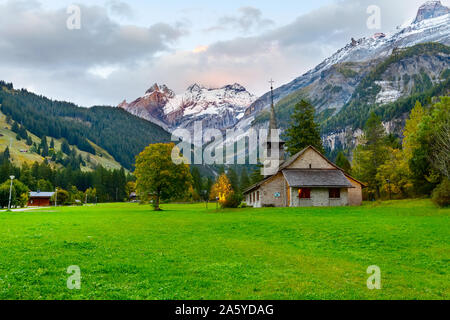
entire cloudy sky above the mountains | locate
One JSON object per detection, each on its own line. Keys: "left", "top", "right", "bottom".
{"left": 0, "top": 0, "right": 444, "bottom": 106}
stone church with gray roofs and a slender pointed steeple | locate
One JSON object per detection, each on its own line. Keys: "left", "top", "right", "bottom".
{"left": 244, "top": 84, "right": 365, "bottom": 208}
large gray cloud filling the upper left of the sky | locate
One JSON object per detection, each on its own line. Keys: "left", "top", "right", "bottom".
{"left": 0, "top": 1, "right": 185, "bottom": 68}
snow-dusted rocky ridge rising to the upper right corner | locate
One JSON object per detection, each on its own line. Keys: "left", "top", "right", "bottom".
{"left": 242, "top": 1, "right": 450, "bottom": 122}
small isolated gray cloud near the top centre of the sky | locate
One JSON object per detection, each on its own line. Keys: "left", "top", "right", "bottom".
{"left": 206, "top": 7, "right": 275, "bottom": 32}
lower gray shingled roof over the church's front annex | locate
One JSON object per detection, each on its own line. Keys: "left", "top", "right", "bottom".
{"left": 283, "top": 169, "right": 353, "bottom": 188}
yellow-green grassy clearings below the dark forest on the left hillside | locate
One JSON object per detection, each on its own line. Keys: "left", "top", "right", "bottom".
{"left": 0, "top": 112, "right": 121, "bottom": 170}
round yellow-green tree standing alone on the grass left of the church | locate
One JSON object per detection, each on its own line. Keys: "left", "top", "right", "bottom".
{"left": 134, "top": 143, "right": 192, "bottom": 211}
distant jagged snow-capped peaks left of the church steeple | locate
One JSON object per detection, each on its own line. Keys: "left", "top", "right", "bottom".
{"left": 119, "top": 83, "right": 256, "bottom": 131}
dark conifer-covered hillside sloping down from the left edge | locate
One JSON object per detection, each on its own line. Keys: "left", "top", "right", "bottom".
{"left": 0, "top": 81, "right": 170, "bottom": 169}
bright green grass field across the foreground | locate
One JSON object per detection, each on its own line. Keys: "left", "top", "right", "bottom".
{"left": 0, "top": 200, "right": 450, "bottom": 299}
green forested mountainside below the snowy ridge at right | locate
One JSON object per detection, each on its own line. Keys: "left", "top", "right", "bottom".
{"left": 322, "top": 43, "right": 450, "bottom": 133}
